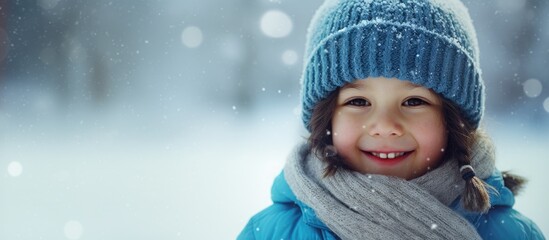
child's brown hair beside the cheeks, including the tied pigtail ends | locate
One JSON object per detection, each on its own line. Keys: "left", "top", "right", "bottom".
{"left": 308, "top": 89, "right": 525, "bottom": 212}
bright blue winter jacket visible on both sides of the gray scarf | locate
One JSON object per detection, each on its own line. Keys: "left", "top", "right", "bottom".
{"left": 238, "top": 171, "right": 545, "bottom": 240}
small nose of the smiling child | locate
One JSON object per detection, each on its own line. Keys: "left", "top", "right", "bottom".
{"left": 365, "top": 111, "right": 403, "bottom": 137}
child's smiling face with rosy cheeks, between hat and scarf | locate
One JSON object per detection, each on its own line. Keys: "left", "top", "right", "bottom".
{"left": 332, "top": 77, "right": 447, "bottom": 179}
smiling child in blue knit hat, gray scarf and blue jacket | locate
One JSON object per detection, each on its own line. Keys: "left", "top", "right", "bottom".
{"left": 238, "top": 0, "right": 545, "bottom": 239}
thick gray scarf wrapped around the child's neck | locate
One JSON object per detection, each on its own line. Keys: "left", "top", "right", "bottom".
{"left": 284, "top": 138, "right": 495, "bottom": 239}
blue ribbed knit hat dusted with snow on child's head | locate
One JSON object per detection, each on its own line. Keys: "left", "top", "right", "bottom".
{"left": 301, "top": 0, "right": 484, "bottom": 130}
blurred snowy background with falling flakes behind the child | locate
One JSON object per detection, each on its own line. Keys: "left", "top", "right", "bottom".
{"left": 0, "top": 0, "right": 549, "bottom": 240}
